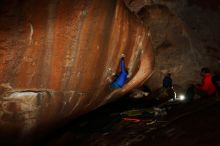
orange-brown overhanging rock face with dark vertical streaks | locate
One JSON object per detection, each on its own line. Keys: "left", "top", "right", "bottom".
{"left": 0, "top": 0, "right": 153, "bottom": 135}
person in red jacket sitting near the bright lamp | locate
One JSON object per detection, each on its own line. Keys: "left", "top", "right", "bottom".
{"left": 196, "top": 67, "right": 216, "bottom": 97}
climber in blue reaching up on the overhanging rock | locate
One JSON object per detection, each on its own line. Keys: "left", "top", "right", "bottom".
{"left": 111, "top": 56, "right": 128, "bottom": 89}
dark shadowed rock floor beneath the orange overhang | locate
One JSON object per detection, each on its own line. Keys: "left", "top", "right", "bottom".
{"left": 35, "top": 98, "right": 220, "bottom": 146}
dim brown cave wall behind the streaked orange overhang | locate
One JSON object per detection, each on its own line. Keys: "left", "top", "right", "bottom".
{"left": 125, "top": 0, "right": 220, "bottom": 92}
